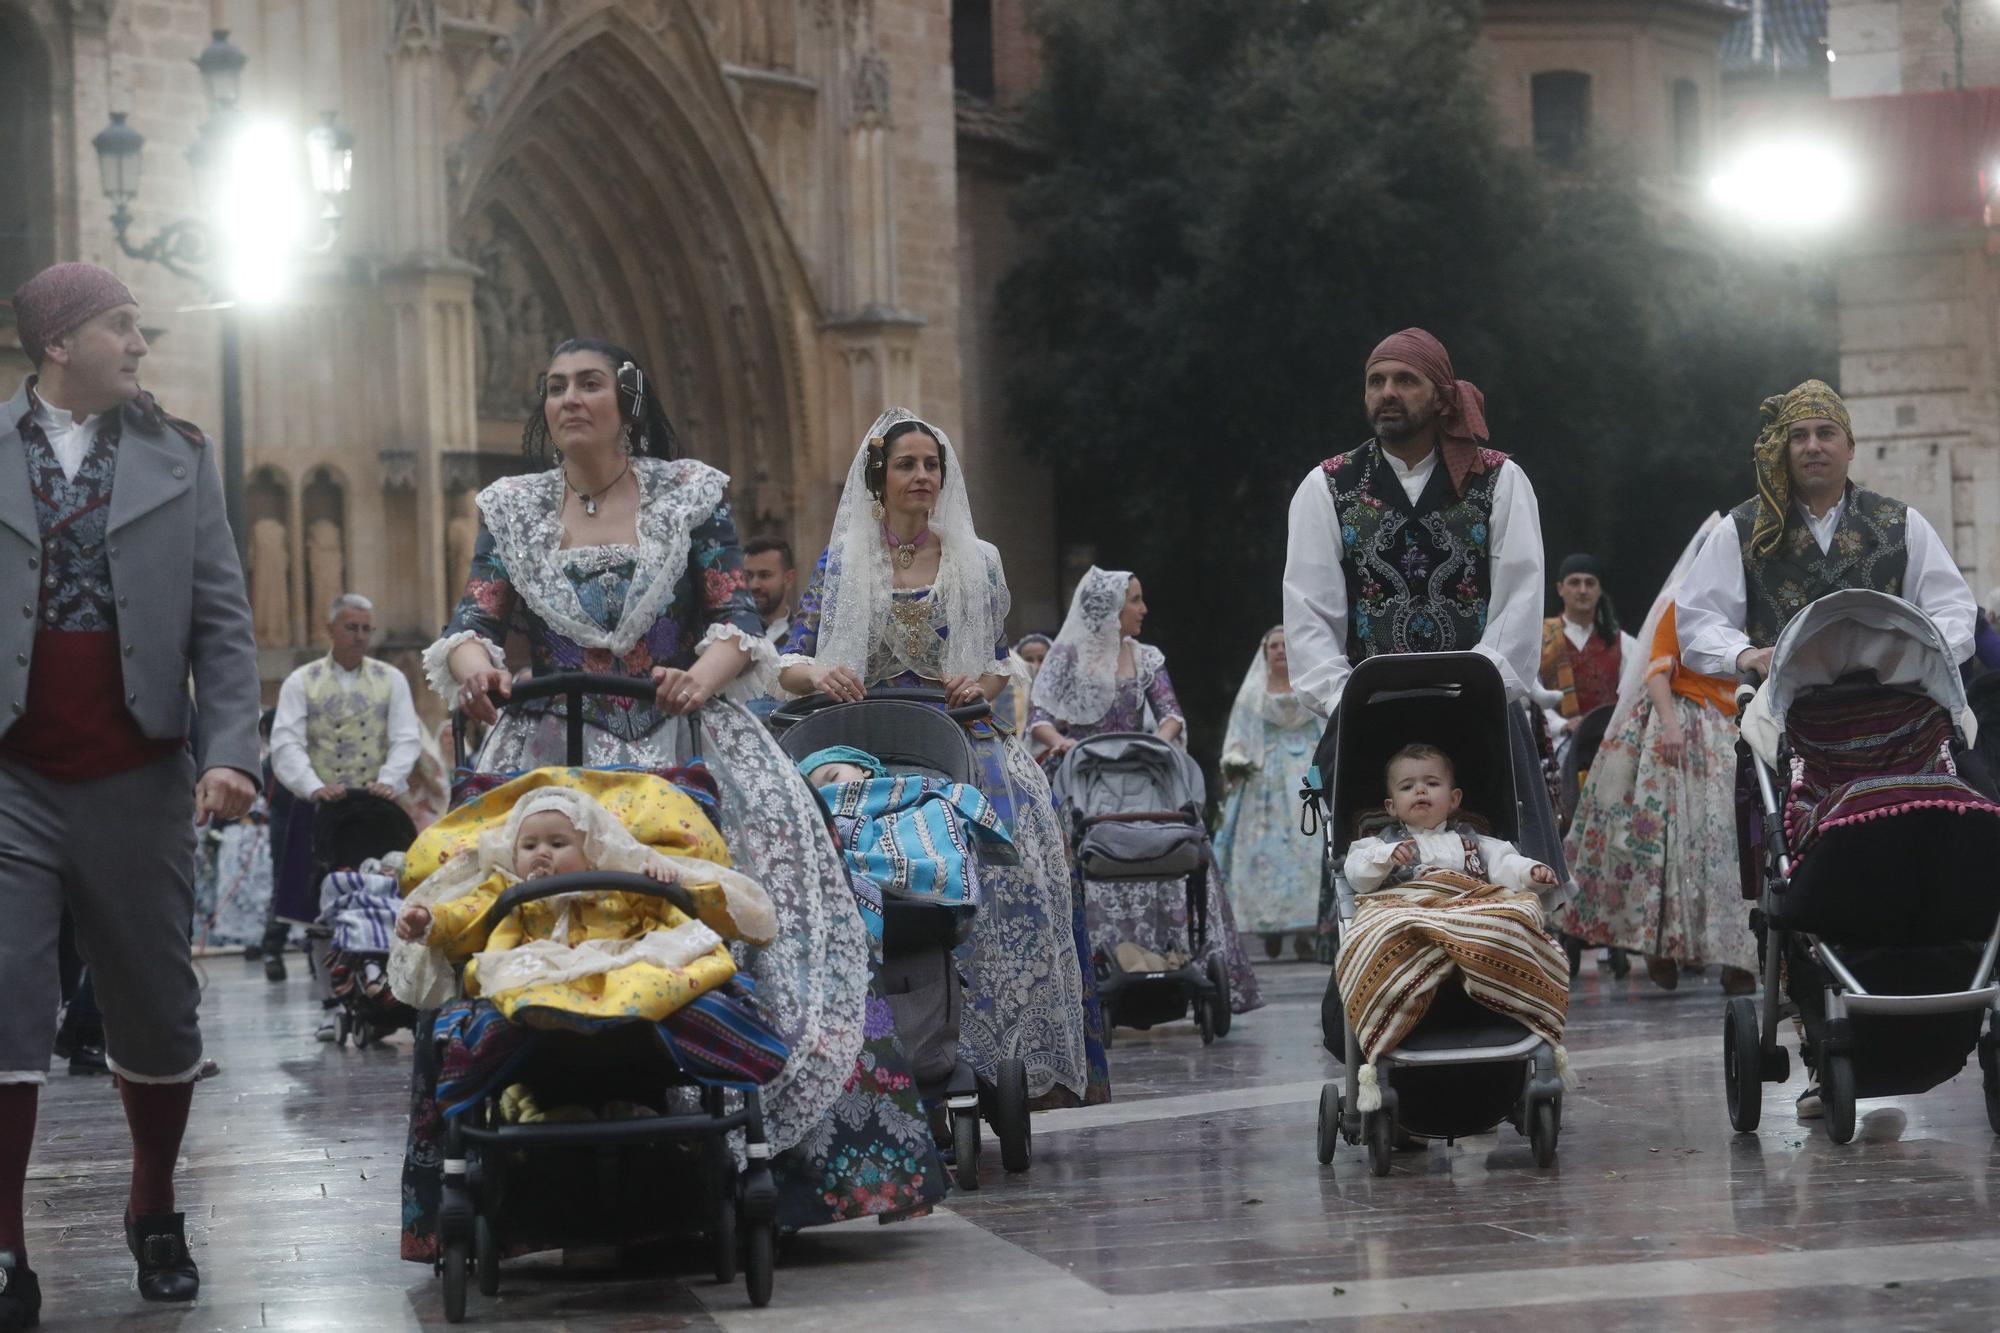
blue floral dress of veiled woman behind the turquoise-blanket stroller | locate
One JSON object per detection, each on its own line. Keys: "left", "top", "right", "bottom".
{"left": 782, "top": 552, "right": 1110, "bottom": 1109}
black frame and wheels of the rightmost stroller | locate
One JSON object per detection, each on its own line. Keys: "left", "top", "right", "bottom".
{"left": 1722, "top": 590, "right": 2000, "bottom": 1143}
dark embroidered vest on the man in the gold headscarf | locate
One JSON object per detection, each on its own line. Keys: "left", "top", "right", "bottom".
{"left": 1730, "top": 482, "right": 1910, "bottom": 648}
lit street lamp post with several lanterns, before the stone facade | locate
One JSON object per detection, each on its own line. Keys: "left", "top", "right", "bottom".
{"left": 90, "top": 28, "right": 354, "bottom": 568}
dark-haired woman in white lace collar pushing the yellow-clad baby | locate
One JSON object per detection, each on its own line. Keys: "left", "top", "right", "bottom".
{"left": 404, "top": 338, "right": 948, "bottom": 1232}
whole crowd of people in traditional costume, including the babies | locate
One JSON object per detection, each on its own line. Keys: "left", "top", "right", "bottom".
{"left": 0, "top": 252, "right": 2000, "bottom": 1329}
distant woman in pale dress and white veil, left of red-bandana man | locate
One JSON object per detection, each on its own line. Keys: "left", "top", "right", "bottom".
{"left": 1216, "top": 624, "right": 1322, "bottom": 959}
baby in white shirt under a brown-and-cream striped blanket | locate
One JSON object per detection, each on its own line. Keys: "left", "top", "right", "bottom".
{"left": 1334, "top": 745, "right": 1570, "bottom": 1111}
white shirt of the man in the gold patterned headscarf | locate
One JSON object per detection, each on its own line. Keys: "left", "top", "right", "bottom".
{"left": 1674, "top": 494, "right": 1978, "bottom": 681}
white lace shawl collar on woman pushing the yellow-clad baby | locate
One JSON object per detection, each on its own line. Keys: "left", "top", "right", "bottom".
{"left": 478, "top": 458, "right": 730, "bottom": 656}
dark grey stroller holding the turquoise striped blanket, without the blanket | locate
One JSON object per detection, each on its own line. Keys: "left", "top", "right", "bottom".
{"left": 770, "top": 689, "right": 1032, "bottom": 1189}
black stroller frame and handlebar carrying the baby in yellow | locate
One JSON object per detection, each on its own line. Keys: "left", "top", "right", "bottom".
{"left": 430, "top": 673, "right": 778, "bottom": 1323}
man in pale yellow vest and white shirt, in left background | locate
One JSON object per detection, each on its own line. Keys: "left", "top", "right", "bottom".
{"left": 264, "top": 592, "right": 424, "bottom": 1008}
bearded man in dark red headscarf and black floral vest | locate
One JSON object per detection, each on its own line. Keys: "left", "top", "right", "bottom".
{"left": 1284, "top": 328, "right": 1570, "bottom": 1012}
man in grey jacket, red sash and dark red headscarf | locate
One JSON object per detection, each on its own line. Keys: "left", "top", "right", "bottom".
{"left": 0, "top": 264, "right": 260, "bottom": 1333}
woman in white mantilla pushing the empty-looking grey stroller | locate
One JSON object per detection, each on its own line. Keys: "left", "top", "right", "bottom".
{"left": 1028, "top": 564, "right": 1264, "bottom": 1013}
